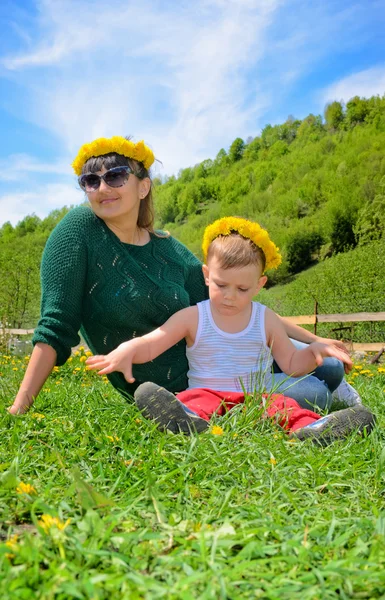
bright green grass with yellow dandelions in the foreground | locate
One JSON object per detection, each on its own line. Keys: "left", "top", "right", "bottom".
{"left": 0, "top": 352, "right": 385, "bottom": 600}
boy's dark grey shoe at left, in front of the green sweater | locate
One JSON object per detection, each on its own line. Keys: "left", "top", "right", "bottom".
{"left": 134, "top": 381, "right": 209, "bottom": 435}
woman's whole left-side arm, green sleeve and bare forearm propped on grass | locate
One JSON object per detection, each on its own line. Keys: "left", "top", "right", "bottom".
{"left": 9, "top": 207, "right": 89, "bottom": 415}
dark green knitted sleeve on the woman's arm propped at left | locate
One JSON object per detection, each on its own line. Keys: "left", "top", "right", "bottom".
{"left": 32, "top": 207, "right": 93, "bottom": 365}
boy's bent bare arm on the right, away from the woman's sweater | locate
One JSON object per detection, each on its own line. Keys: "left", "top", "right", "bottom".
{"left": 265, "top": 308, "right": 352, "bottom": 377}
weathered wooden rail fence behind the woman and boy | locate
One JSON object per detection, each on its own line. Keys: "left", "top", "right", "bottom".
{"left": 0, "top": 310, "right": 385, "bottom": 352}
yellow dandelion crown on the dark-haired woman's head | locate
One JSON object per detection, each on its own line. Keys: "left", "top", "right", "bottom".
{"left": 71, "top": 135, "right": 155, "bottom": 175}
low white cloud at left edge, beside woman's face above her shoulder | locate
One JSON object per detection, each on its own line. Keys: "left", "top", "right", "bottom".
{"left": 0, "top": 183, "right": 84, "bottom": 225}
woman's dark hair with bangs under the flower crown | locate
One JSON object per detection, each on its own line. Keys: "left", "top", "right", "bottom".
{"left": 82, "top": 144, "right": 154, "bottom": 232}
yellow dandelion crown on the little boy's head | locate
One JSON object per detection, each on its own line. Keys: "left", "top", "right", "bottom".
{"left": 202, "top": 217, "right": 282, "bottom": 270}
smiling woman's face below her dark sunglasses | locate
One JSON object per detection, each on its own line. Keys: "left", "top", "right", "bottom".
{"left": 87, "top": 167, "right": 151, "bottom": 224}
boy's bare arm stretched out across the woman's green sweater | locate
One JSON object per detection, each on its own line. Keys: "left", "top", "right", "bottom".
{"left": 86, "top": 306, "right": 198, "bottom": 383}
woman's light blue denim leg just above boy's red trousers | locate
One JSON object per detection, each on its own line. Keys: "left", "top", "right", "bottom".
{"left": 269, "top": 373, "right": 332, "bottom": 410}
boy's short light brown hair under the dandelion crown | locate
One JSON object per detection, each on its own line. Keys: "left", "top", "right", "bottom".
{"left": 207, "top": 231, "right": 266, "bottom": 273}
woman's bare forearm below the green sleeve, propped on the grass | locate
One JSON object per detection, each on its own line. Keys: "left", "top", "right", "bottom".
{"left": 8, "top": 343, "right": 56, "bottom": 415}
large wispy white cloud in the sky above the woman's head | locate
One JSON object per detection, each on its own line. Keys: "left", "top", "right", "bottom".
{"left": 3, "top": 0, "right": 279, "bottom": 174}
